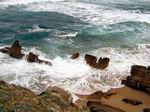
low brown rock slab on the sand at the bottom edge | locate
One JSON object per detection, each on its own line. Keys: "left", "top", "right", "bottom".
{"left": 87, "top": 101, "right": 124, "bottom": 112}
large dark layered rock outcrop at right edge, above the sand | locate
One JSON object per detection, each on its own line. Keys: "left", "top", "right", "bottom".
{"left": 122, "top": 65, "right": 150, "bottom": 93}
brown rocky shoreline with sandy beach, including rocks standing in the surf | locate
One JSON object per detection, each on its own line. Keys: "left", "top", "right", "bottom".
{"left": 0, "top": 41, "right": 150, "bottom": 112}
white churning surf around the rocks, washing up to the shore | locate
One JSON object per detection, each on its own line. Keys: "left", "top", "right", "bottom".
{"left": 0, "top": 44, "right": 150, "bottom": 94}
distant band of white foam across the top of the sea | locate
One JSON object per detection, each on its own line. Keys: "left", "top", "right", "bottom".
{"left": 0, "top": 0, "right": 150, "bottom": 25}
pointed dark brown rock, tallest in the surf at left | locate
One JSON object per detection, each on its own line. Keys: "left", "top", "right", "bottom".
{"left": 8, "top": 40, "right": 23, "bottom": 59}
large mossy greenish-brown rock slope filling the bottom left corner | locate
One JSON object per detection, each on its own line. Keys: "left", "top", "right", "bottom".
{"left": 0, "top": 81, "right": 86, "bottom": 112}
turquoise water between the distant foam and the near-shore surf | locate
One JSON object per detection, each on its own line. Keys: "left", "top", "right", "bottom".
{"left": 0, "top": 1, "right": 150, "bottom": 57}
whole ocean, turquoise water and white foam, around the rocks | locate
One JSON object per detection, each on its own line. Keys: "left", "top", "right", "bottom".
{"left": 0, "top": 0, "right": 150, "bottom": 94}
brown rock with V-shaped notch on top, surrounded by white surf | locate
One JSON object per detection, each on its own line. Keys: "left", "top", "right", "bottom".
{"left": 85, "top": 54, "right": 110, "bottom": 70}
